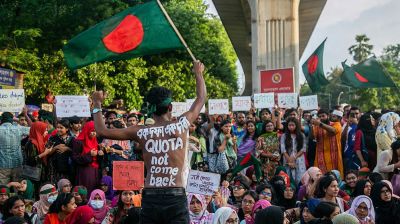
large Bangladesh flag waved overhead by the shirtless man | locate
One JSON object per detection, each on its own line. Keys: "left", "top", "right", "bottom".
{"left": 64, "top": 1, "right": 184, "bottom": 69}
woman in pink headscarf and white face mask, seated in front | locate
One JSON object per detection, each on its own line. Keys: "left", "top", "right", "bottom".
{"left": 88, "top": 189, "right": 110, "bottom": 224}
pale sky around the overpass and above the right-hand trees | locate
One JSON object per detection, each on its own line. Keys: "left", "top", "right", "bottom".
{"left": 205, "top": 0, "right": 400, "bottom": 88}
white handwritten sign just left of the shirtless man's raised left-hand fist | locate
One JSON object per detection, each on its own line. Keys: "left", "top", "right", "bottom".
{"left": 56, "top": 96, "right": 90, "bottom": 117}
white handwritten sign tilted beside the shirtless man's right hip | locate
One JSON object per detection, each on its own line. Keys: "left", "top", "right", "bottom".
{"left": 186, "top": 170, "right": 221, "bottom": 195}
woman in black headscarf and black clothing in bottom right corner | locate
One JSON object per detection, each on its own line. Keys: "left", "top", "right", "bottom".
{"left": 371, "top": 182, "right": 400, "bottom": 224}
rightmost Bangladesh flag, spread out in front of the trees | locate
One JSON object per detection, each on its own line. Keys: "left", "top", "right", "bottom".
{"left": 341, "top": 57, "right": 396, "bottom": 88}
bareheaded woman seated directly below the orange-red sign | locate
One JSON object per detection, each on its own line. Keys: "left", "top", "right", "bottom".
{"left": 101, "top": 191, "right": 135, "bottom": 224}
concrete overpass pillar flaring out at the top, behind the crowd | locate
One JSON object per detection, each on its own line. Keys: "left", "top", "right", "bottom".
{"left": 213, "top": 0, "right": 327, "bottom": 95}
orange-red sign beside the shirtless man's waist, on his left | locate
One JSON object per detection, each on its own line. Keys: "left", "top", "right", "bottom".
{"left": 113, "top": 161, "right": 144, "bottom": 191}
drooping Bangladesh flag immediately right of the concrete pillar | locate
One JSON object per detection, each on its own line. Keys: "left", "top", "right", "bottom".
{"left": 302, "top": 39, "right": 329, "bottom": 92}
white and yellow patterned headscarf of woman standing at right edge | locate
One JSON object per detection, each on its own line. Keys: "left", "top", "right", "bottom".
{"left": 375, "top": 112, "right": 400, "bottom": 158}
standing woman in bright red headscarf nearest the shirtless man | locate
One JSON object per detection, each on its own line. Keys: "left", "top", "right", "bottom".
{"left": 72, "top": 121, "right": 104, "bottom": 192}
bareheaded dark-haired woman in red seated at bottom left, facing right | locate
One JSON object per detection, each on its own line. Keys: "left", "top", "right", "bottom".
{"left": 43, "top": 193, "right": 76, "bottom": 224}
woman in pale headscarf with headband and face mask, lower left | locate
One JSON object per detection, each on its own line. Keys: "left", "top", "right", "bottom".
{"left": 32, "top": 184, "right": 58, "bottom": 223}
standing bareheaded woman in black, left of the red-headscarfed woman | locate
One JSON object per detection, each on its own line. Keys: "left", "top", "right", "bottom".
{"left": 47, "top": 119, "right": 73, "bottom": 183}
